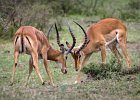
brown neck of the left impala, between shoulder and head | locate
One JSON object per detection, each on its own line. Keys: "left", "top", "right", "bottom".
{"left": 48, "top": 47, "right": 62, "bottom": 61}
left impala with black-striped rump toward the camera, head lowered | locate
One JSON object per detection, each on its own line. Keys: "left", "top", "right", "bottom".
{"left": 11, "top": 24, "right": 75, "bottom": 85}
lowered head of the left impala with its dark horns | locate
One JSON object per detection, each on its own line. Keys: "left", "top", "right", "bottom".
{"left": 55, "top": 24, "right": 76, "bottom": 74}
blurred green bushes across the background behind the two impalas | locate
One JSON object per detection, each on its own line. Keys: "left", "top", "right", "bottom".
{"left": 0, "top": 0, "right": 140, "bottom": 38}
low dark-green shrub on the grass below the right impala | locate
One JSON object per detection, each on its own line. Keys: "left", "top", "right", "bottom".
{"left": 82, "top": 57, "right": 140, "bottom": 79}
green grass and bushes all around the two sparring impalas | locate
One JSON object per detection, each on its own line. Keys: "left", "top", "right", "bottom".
{"left": 0, "top": 0, "right": 140, "bottom": 100}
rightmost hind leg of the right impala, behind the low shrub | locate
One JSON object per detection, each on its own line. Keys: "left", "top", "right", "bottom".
{"left": 119, "top": 39, "right": 131, "bottom": 68}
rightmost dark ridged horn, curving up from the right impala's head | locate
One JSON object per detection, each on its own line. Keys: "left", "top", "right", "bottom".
{"left": 74, "top": 21, "right": 89, "bottom": 54}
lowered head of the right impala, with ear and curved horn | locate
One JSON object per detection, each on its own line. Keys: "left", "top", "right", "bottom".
{"left": 66, "top": 22, "right": 89, "bottom": 71}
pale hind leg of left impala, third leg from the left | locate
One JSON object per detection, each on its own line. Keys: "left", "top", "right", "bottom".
{"left": 31, "top": 51, "right": 44, "bottom": 85}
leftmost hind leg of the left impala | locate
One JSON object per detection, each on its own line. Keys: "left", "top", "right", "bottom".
{"left": 11, "top": 51, "right": 19, "bottom": 85}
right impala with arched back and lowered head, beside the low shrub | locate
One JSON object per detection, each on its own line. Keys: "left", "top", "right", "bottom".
{"left": 66, "top": 18, "right": 131, "bottom": 82}
